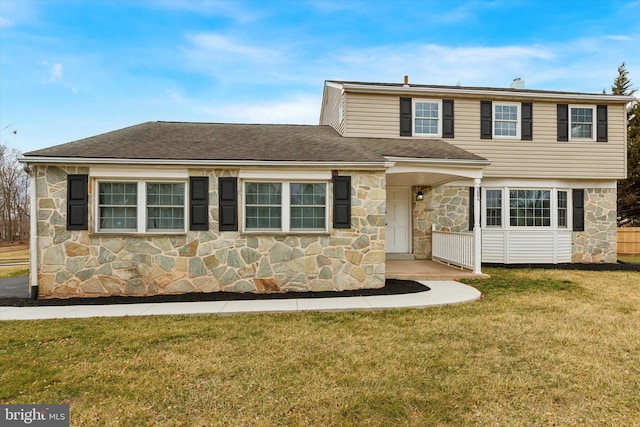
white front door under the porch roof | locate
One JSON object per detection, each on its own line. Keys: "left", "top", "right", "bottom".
{"left": 386, "top": 187, "right": 411, "bottom": 254}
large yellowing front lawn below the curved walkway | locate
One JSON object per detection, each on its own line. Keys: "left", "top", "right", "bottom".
{"left": 0, "top": 269, "right": 640, "bottom": 426}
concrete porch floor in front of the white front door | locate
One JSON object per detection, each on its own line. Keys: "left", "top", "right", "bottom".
{"left": 385, "top": 259, "right": 489, "bottom": 280}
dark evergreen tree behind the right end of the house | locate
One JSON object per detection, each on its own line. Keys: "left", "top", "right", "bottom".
{"left": 611, "top": 62, "right": 640, "bottom": 227}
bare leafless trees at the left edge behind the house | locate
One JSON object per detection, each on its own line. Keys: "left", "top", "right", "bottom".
{"left": 0, "top": 143, "right": 29, "bottom": 241}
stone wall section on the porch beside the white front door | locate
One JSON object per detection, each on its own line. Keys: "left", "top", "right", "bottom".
{"left": 412, "top": 185, "right": 469, "bottom": 259}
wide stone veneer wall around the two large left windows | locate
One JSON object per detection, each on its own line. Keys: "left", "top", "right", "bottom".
{"left": 34, "top": 166, "right": 386, "bottom": 298}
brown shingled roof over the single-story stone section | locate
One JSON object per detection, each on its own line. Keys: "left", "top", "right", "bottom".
{"left": 24, "top": 122, "right": 486, "bottom": 163}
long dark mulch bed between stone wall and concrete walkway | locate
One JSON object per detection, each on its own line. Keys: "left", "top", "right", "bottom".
{"left": 0, "top": 279, "right": 430, "bottom": 307}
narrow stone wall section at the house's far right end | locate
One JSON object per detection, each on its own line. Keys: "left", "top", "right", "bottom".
{"left": 571, "top": 188, "right": 618, "bottom": 263}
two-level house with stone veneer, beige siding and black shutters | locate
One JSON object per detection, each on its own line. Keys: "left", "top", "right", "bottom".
{"left": 21, "top": 78, "right": 631, "bottom": 298}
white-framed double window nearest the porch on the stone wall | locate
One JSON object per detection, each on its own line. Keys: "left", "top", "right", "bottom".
{"left": 244, "top": 182, "right": 328, "bottom": 232}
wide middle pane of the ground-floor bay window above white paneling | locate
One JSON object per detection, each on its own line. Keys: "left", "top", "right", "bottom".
{"left": 509, "top": 190, "right": 551, "bottom": 227}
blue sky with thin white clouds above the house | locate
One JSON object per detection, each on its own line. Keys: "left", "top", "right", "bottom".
{"left": 0, "top": 0, "right": 640, "bottom": 152}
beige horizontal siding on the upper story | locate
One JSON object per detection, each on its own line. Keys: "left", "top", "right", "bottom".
{"left": 322, "top": 88, "right": 626, "bottom": 180}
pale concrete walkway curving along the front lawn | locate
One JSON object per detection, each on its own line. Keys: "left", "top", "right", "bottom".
{"left": 0, "top": 281, "right": 481, "bottom": 320}
